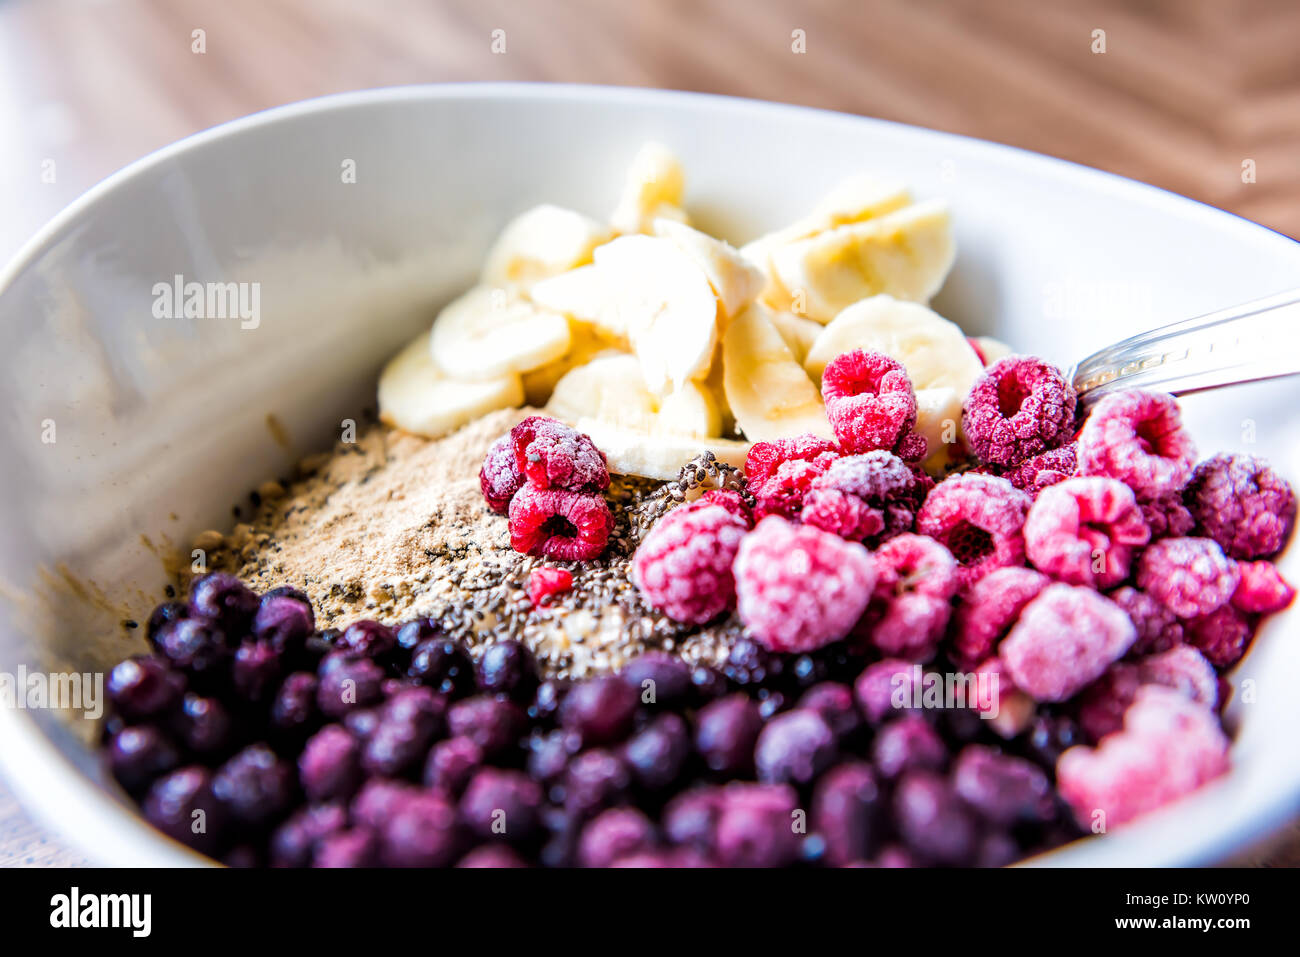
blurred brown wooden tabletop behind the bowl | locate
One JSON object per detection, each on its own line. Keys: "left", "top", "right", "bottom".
{"left": 0, "top": 0, "right": 1300, "bottom": 866}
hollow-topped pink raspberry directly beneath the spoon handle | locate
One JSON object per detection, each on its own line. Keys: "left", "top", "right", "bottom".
{"left": 1079, "top": 389, "right": 1196, "bottom": 499}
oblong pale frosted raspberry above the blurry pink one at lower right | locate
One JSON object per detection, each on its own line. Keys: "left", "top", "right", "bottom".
{"left": 998, "top": 585, "right": 1138, "bottom": 701}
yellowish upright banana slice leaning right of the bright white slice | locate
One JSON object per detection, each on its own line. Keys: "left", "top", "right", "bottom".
{"left": 723, "top": 303, "right": 832, "bottom": 442}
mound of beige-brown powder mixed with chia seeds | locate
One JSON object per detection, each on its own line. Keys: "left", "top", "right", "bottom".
{"left": 195, "top": 408, "right": 741, "bottom": 677}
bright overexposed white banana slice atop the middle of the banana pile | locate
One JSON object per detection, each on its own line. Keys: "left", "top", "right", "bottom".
{"left": 595, "top": 235, "right": 719, "bottom": 395}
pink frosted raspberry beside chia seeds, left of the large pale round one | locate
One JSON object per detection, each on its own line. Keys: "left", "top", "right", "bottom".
{"left": 632, "top": 499, "right": 749, "bottom": 624}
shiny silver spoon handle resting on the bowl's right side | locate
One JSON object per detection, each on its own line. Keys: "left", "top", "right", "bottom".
{"left": 1070, "top": 289, "right": 1300, "bottom": 403}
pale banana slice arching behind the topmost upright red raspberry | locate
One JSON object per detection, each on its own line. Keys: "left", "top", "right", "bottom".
{"left": 803, "top": 295, "right": 983, "bottom": 399}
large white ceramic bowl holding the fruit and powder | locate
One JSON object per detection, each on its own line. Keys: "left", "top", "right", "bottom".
{"left": 0, "top": 85, "right": 1300, "bottom": 865}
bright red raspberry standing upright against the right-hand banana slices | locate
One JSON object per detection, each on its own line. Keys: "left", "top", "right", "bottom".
{"left": 822, "top": 348, "right": 917, "bottom": 452}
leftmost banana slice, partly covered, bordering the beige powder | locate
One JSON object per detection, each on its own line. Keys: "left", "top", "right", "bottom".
{"left": 380, "top": 333, "right": 524, "bottom": 438}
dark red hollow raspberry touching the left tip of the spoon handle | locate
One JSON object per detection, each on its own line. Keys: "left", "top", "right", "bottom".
{"left": 962, "top": 355, "right": 1076, "bottom": 465}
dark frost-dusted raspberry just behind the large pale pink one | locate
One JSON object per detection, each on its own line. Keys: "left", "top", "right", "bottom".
{"left": 800, "top": 450, "right": 935, "bottom": 549}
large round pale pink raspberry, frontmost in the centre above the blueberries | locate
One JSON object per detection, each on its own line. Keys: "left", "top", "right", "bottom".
{"left": 736, "top": 515, "right": 876, "bottom": 651}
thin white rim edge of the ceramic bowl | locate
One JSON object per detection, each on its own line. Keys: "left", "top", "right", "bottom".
{"left": 0, "top": 82, "right": 1300, "bottom": 866}
